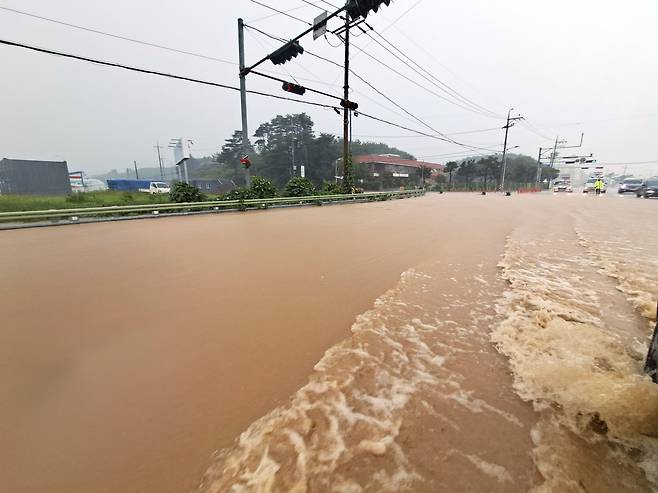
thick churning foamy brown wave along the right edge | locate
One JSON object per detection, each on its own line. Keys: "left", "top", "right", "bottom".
{"left": 492, "top": 217, "right": 658, "bottom": 492}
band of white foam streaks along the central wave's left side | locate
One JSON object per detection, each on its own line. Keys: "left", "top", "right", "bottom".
{"left": 199, "top": 270, "right": 454, "bottom": 493}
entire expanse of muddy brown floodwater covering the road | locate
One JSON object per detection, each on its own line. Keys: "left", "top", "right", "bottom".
{"left": 0, "top": 194, "right": 658, "bottom": 493}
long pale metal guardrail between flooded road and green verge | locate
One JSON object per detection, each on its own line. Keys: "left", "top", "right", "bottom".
{"left": 0, "top": 190, "right": 425, "bottom": 223}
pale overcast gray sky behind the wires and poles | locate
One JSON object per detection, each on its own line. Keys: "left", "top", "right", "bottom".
{"left": 0, "top": 0, "right": 658, "bottom": 177}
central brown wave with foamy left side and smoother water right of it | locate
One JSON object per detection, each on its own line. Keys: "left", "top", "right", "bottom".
{"left": 193, "top": 258, "right": 534, "bottom": 493}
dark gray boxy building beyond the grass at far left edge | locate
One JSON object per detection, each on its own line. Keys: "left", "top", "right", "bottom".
{"left": 0, "top": 159, "right": 71, "bottom": 195}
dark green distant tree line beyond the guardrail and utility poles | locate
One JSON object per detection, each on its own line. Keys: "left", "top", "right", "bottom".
{"left": 92, "top": 113, "right": 556, "bottom": 190}
